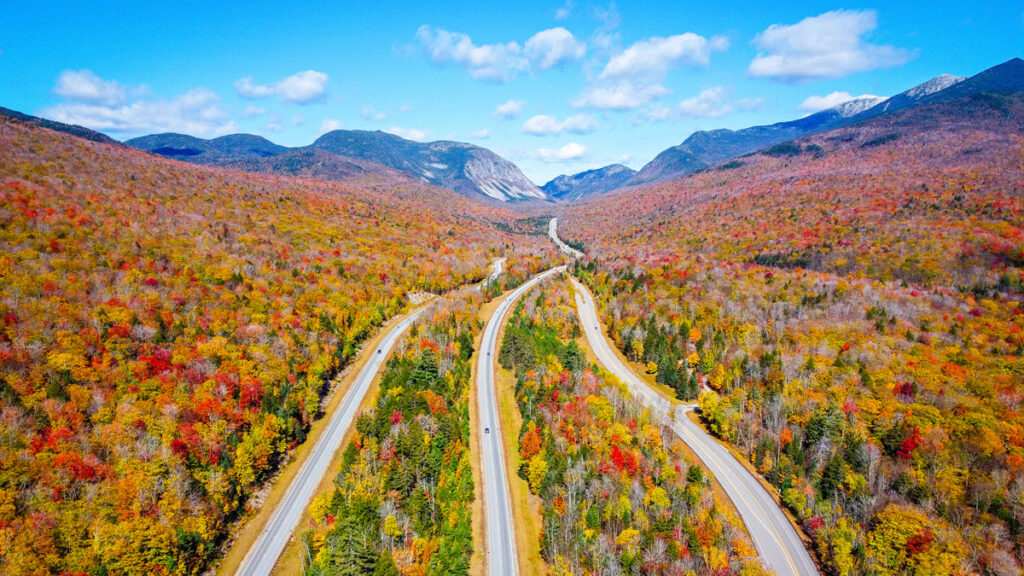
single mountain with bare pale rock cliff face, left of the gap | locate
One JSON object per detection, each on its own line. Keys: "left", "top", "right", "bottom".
{"left": 311, "top": 130, "right": 547, "bottom": 202}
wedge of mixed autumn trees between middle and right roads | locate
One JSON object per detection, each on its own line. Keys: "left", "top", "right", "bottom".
{"left": 499, "top": 277, "right": 763, "bottom": 575}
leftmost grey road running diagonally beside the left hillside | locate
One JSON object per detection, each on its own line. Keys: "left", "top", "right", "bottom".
{"left": 234, "top": 307, "right": 426, "bottom": 576}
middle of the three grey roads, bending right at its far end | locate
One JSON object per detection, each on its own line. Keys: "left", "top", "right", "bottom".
{"left": 476, "top": 266, "right": 565, "bottom": 576}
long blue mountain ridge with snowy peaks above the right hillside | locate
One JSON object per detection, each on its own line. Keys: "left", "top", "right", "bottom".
{"left": 626, "top": 58, "right": 1024, "bottom": 186}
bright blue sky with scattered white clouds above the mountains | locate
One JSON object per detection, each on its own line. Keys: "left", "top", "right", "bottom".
{"left": 0, "top": 0, "right": 1024, "bottom": 184}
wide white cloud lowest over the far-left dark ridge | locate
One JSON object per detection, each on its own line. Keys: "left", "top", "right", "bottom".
{"left": 39, "top": 84, "right": 238, "bottom": 137}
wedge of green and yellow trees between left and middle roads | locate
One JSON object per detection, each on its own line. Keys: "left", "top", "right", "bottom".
{"left": 303, "top": 291, "right": 482, "bottom": 575}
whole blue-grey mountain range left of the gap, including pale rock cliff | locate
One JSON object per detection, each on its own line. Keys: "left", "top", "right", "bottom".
{"left": 125, "top": 130, "right": 548, "bottom": 202}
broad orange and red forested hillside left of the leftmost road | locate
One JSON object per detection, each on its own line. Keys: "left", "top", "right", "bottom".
{"left": 0, "top": 119, "right": 539, "bottom": 575}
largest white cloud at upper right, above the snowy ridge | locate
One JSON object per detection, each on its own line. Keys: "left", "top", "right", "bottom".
{"left": 746, "top": 10, "right": 913, "bottom": 83}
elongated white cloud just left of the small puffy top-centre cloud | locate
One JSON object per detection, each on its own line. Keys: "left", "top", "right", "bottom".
{"left": 416, "top": 25, "right": 529, "bottom": 82}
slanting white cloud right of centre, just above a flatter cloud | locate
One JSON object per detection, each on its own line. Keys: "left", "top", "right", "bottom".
{"left": 600, "top": 32, "right": 729, "bottom": 81}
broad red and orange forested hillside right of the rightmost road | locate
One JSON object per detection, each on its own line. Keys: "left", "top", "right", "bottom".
{"left": 559, "top": 94, "right": 1024, "bottom": 575}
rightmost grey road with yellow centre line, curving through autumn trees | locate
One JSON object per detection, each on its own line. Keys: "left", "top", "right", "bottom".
{"left": 572, "top": 279, "right": 818, "bottom": 576}
